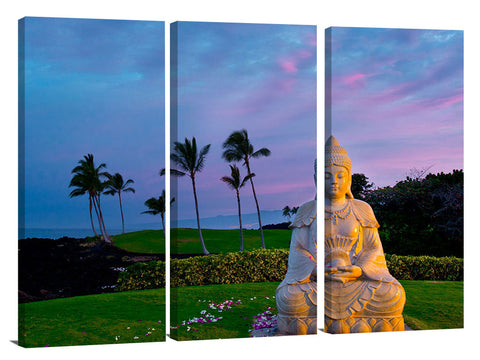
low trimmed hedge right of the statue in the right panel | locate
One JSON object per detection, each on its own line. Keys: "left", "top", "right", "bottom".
{"left": 385, "top": 254, "right": 463, "bottom": 281}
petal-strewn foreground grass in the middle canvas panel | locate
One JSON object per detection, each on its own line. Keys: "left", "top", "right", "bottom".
{"left": 170, "top": 282, "right": 280, "bottom": 340}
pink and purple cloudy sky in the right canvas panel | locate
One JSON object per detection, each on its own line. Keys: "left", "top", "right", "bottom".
{"left": 325, "top": 27, "right": 463, "bottom": 187}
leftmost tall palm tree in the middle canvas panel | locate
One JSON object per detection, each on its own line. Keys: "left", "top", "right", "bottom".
{"left": 171, "top": 137, "right": 210, "bottom": 255}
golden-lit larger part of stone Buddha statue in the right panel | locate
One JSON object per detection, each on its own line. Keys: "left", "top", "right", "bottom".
{"left": 325, "top": 136, "right": 405, "bottom": 334}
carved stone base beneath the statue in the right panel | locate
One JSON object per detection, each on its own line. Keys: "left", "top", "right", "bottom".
{"left": 325, "top": 316, "right": 405, "bottom": 334}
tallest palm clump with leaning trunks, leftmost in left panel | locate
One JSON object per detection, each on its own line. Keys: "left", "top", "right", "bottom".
{"left": 69, "top": 154, "right": 111, "bottom": 243}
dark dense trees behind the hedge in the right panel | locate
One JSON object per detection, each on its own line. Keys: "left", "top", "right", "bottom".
{"left": 352, "top": 170, "right": 463, "bottom": 257}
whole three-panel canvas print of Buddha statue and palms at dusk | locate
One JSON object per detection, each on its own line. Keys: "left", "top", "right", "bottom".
{"left": 19, "top": 18, "right": 463, "bottom": 347}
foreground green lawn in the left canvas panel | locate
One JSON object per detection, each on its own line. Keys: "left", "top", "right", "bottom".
{"left": 18, "top": 289, "right": 165, "bottom": 347}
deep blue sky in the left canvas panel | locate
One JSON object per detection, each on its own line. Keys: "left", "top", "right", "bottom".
{"left": 20, "top": 18, "right": 165, "bottom": 229}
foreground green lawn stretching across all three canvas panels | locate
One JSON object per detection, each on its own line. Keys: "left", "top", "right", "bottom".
{"left": 19, "top": 280, "right": 463, "bottom": 347}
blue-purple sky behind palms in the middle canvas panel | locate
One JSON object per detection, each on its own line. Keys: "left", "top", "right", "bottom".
{"left": 171, "top": 22, "right": 317, "bottom": 222}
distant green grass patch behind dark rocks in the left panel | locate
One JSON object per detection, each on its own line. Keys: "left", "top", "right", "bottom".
{"left": 113, "top": 230, "right": 165, "bottom": 254}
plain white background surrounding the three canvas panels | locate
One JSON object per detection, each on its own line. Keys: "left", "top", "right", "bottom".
{"left": 0, "top": 0, "right": 480, "bottom": 360}
